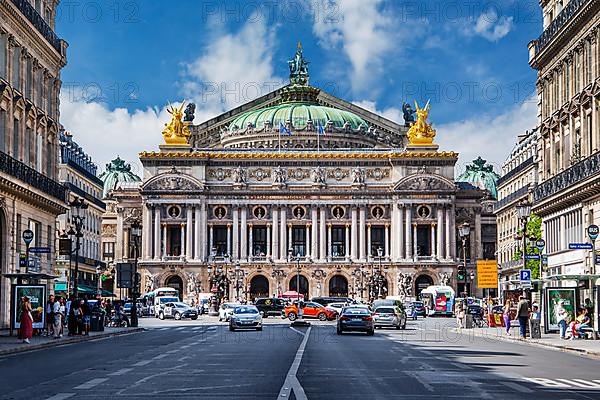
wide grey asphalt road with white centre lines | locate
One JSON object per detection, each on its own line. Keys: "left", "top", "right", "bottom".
{"left": 0, "top": 318, "right": 600, "bottom": 400}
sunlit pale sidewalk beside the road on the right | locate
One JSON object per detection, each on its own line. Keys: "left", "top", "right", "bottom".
{"left": 453, "top": 327, "right": 600, "bottom": 357}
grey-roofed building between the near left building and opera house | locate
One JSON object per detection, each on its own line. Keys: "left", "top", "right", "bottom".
{"left": 55, "top": 131, "right": 106, "bottom": 295}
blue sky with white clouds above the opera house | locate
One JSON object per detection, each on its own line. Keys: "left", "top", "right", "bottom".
{"left": 57, "top": 0, "right": 541, "bottom": 173}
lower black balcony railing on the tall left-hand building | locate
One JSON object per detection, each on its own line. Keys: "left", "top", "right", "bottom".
{"left": 0, "top": 152, "right": 67, "bottom": 203}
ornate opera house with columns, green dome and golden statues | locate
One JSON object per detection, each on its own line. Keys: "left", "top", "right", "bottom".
{"left": 131, "top": 49, "right": 492, "bottom": 299}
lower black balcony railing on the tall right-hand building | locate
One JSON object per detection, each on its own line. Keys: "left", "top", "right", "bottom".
{"left": 533, "top": 153, "right": 600, "bottom": 202}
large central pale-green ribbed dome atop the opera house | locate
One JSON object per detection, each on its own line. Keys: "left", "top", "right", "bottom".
{"left": 229, "top": 102, "right": 368, "bottom": 131}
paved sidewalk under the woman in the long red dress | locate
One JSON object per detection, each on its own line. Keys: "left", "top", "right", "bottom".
{"left": 0, "top": 328, "right": 144, "bottom": 356}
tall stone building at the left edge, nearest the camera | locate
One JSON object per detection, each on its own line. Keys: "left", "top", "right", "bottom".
{"left": 0, "top": 0, "right": 67, "bottom": 328}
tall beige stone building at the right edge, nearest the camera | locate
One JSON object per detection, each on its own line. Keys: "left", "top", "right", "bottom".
{"left": 529, "top": 0, "right": 600, "bottom": 296}
